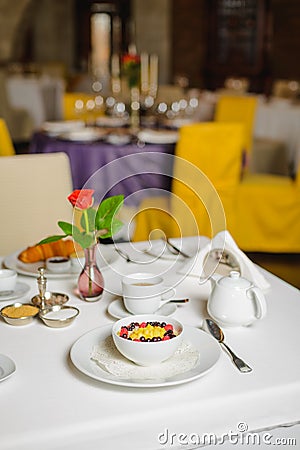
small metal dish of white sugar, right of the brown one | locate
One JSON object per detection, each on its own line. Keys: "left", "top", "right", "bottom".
{"left": 39, "top": 305, "right": 79, "bottom": 328}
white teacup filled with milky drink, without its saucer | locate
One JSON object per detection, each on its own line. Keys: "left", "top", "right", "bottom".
{"left": 122, "top": 273, "right": 175, "bottom": 314}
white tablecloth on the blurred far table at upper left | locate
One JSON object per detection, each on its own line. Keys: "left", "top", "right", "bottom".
{"left": 6, "top": 75, "right": 64, "bottom": 130}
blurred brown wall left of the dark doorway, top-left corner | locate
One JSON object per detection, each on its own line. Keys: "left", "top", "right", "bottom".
{"left": 0, "top": 0, "right": 74, "bottom": 71}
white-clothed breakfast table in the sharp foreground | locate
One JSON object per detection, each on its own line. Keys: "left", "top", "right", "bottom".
{"left": 0, "top": 236, "right": 300, "bottom": 450}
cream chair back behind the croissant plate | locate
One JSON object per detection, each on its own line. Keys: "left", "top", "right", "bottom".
{"left": 0, "top": 153, "right": 73, "bottom": 256}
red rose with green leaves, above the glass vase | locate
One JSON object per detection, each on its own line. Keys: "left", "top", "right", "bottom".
{"left": 39, "top": 189, "right": 124, "bottom": 249}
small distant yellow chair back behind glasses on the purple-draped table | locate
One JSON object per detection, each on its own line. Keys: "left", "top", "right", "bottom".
{"left": 63, "top": 92, "right": 103, "bottom": 123}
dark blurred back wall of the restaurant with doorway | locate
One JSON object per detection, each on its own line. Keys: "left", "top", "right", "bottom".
{"left": 0, "top": 0, "right": 300, "bottom": 94}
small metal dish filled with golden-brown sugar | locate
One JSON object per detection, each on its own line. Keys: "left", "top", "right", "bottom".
{"left": 0, "top": 302, "right": 39, "bottom": 325}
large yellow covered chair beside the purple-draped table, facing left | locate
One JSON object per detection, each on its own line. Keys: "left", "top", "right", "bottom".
{"left": 133, "top": 122, "right": 244, "bottom": 241}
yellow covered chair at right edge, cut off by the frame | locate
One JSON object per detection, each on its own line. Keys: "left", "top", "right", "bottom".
{"left": 233, "top": 167, "right": 300, "bottom": 253}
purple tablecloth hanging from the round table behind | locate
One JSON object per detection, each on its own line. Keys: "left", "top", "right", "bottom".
{"left": 29, "top": 133, "right": 174, "bottom": 205}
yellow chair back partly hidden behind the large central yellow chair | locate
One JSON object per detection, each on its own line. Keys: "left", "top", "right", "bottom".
{"left": 214, "top": 95, "right": 257, "bottom": 158}
